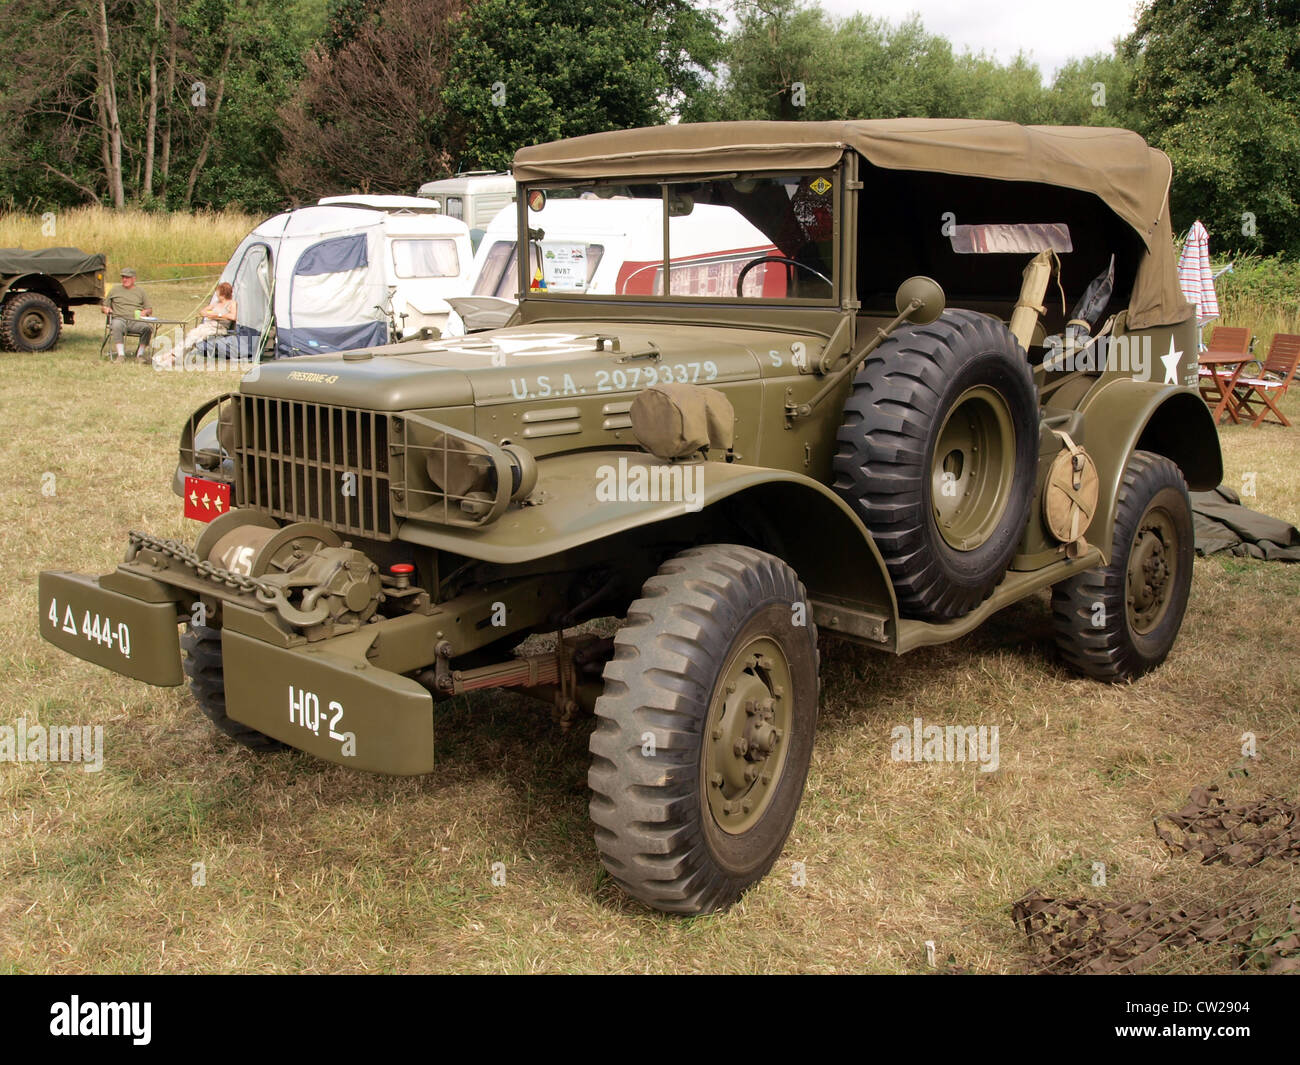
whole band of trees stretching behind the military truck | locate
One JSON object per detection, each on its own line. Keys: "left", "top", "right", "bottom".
{"left": 0, "top": 0, "right": 1300, "bottom": 266}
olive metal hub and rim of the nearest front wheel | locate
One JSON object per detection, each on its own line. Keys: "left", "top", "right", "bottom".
{"left": 705, "top": 636, "right": 793, "bottom": 835}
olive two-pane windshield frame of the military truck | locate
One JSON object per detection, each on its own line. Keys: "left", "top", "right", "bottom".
{"left": 515, "top": 165, "right": 852, "bottom": 309}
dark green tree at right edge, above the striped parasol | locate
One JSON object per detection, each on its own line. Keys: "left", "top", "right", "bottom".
{"left": 1122, "top": 0, "right": 1300, "bottom": 255}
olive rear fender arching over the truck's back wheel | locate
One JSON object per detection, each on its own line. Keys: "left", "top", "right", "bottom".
{"left": 1079, "top": 377, "right": 1223, "bottom": 563}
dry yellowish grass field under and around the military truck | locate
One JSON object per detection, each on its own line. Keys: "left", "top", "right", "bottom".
{"left": 0, "top": 217, "right": 1300, "bottom": 973}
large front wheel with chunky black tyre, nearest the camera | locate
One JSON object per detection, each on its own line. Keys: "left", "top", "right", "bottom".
{"left": 588, "top": 545, "right": 818, "bottom": 914}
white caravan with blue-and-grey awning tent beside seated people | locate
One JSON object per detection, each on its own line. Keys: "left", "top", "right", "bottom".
{"left": 218, "top": 196, "right": 472, "bottom": 356}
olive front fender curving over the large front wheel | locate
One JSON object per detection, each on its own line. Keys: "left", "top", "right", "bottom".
{"left": 397, "top": 450, "right": 898, "bottom": 625}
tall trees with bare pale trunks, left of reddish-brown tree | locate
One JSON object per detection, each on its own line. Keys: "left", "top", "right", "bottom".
{"left": 0, "top": 0, "right": 322, "bottom": 209}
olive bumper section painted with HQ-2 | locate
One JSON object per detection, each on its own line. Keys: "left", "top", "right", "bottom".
{"left": 221, "top": 628, "right": 433, "bottom": 776}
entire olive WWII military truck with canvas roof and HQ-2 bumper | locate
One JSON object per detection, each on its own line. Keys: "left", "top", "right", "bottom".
{"left": 39, "top": 120, "right": 1222, "bottom": 913}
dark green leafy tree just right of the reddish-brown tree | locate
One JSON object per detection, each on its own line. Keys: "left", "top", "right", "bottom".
{"left": 442, "top": 0, "right": 720, "bottom": 169}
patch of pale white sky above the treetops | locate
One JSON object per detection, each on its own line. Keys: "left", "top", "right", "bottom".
{"left": 795, "top": 0, "right": 1138, "bottom": 81}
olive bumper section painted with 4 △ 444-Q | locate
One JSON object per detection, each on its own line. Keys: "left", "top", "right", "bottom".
{"left": 36, "top": 571, "right": 185, "bottom": 688}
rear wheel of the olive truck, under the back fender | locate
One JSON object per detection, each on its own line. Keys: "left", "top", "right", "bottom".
{"left": 1052, "top": 451, "right": 1196, "bottom": 683}
